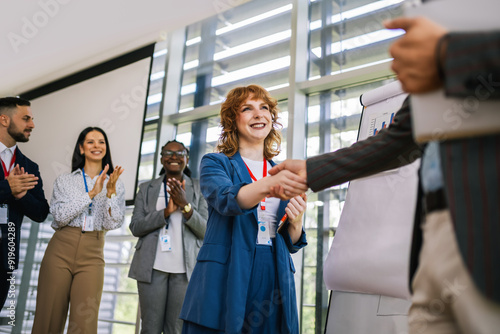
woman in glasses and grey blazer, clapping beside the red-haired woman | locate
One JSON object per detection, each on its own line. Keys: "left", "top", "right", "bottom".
{"left": 129, "top": 140, "right": 208, "bottom": 334}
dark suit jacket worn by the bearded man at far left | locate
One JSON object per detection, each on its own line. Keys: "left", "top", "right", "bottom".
{"left": 0, "top": 147, "right": 49, "bottom": 271}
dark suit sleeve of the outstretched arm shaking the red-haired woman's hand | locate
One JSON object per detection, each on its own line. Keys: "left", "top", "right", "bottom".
{"left": 306, "top": 98, "right": 422, "bottom": 191}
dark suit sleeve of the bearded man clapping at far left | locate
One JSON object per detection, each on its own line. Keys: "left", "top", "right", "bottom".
{"left": 12, "top": 164, "right": 49, "bottom": 223}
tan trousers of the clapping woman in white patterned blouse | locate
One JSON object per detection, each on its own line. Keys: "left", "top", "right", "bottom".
{"left": 32, "top": 227, "right": 104, "bottom": 334}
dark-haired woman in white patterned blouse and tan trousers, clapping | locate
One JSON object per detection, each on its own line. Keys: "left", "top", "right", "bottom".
{"left": 32, "top": 127, "right": 125, "bottom": 334}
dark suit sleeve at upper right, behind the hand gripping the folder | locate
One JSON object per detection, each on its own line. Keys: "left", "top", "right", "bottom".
{"left": 443, "top": 31, "right": 500, "bottom": 101}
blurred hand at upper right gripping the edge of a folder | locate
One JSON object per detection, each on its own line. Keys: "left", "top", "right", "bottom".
{"left": 384, "top": 17, "right": 447, "bottom": 93}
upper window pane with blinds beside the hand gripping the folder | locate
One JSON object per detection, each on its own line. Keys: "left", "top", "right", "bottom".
{"left": 309, "top": 0, "right": 404, "bottom": 79}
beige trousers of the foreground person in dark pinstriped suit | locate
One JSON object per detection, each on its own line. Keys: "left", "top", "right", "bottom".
{"left": 408, "top": 210, "right": 500, "bottom": 334}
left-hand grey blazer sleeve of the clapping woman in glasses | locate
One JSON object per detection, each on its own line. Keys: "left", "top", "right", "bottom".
{"left": 129, "top": 182, "right": 166, "bottom": 237}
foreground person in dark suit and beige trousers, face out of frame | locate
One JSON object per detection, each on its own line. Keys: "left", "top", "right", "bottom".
{"left": 269, "top": 18, "right": 500, "bottom": 334}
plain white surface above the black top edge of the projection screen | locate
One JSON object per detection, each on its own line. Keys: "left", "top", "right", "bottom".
{"left": 0, "top": 0, "right": 249, "bottom": 96}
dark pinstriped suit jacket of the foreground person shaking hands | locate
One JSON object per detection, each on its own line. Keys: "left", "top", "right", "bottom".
{"left": 307, "top": 32, "right": 500, "bottom": 302}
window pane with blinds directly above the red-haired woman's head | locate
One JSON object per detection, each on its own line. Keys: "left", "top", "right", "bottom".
{"left": 179, "top": 0, "right": 292, "bottom": 112}
